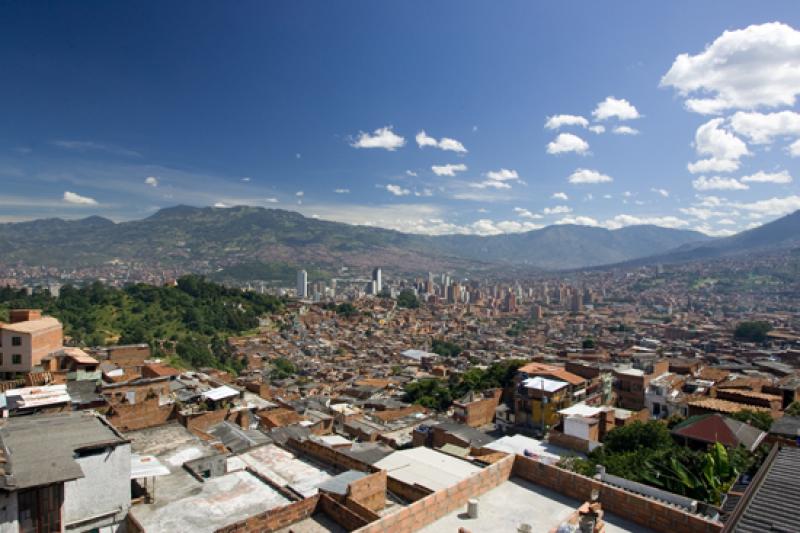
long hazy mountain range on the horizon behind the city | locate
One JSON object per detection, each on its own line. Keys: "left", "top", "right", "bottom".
{"left": 0, "top": 206, "right": 714, "bottom": 272}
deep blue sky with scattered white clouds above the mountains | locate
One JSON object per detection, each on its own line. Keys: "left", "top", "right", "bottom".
{"left": 0, "top": 1, "right": 800, "bottom": 235}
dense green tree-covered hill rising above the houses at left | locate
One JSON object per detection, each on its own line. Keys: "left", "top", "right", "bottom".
{"left": 0, "top": 275, "right": 283, "bottom": 370}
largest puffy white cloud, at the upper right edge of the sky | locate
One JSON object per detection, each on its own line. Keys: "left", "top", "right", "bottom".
{"left": 661, "top": 22, "right": 800, "bottom": 114}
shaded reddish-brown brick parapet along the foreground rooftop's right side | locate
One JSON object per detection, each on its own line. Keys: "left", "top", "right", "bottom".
{"left": 512, "top": 455, "right": 722, "bottom": 533}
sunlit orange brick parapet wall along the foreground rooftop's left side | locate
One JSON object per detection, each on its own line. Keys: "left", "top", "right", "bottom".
{"left": 358, "top": 456, "right": 514, "bottom": 533}
